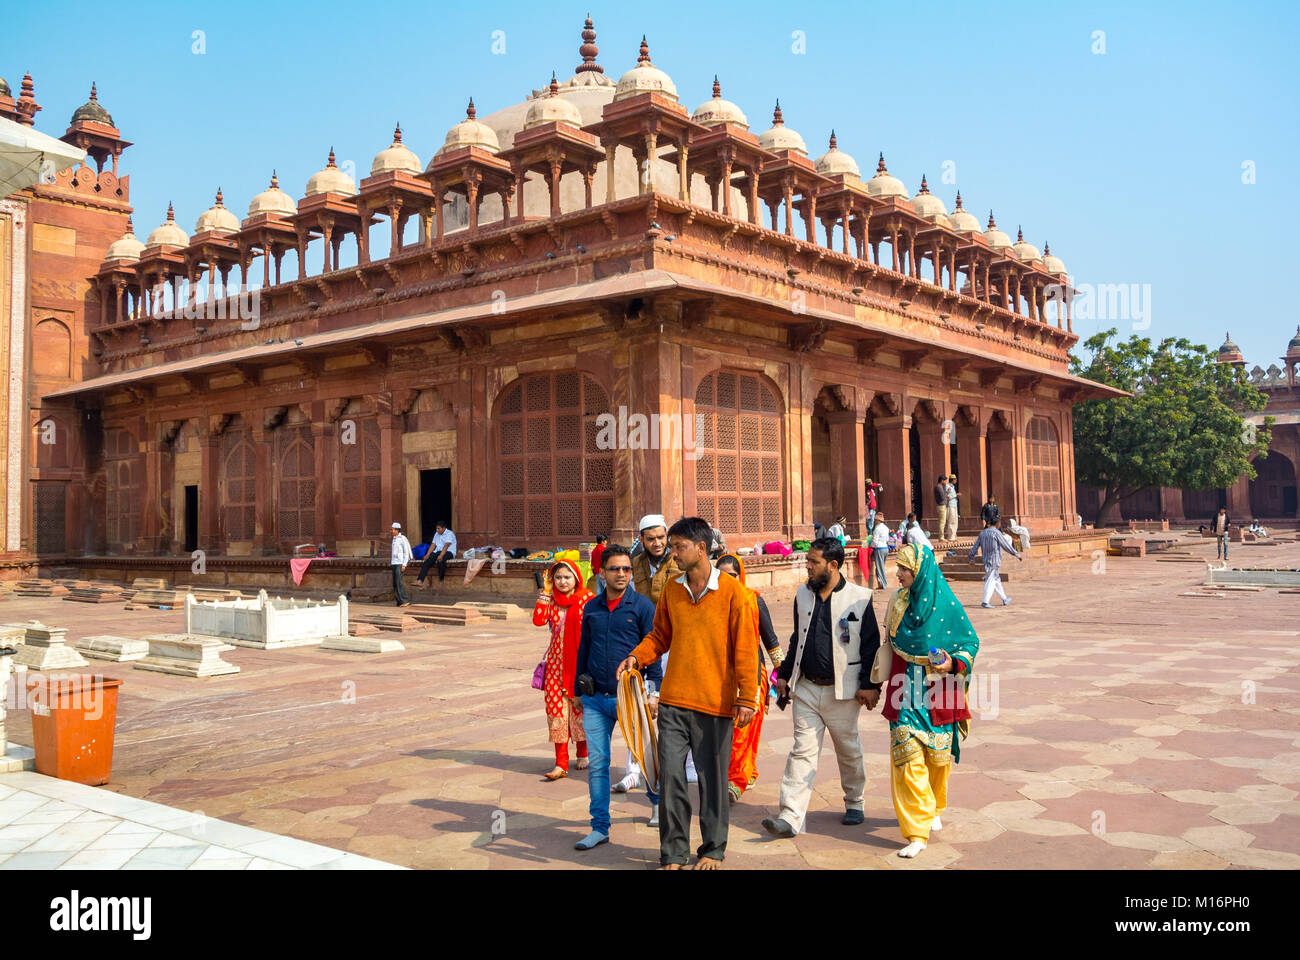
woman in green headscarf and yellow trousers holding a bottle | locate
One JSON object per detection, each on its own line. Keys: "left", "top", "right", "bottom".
{"left": 883, "top": 544, "right": 979, "bottom": 857}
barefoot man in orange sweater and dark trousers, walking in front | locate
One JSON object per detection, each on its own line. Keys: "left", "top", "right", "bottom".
{"left": 619, "top": 516, "right": 758, "bottom": 870}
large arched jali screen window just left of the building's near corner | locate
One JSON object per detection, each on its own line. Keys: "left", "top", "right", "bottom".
{"left": 495, "top": 372, "right": 614, "bottom": 546}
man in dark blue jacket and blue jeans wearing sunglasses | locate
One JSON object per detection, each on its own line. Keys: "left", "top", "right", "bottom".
{"left": 573, "top": 544, "right": 663, "bottom": 849}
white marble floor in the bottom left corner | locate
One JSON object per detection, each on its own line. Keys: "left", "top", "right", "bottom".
{"left": 0, "top": 771, "right": 404, "bottom": 870}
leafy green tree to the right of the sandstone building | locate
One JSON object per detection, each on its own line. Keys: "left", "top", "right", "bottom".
{"left": 1070, "top": 329, "right": 1273, "bottom": 524}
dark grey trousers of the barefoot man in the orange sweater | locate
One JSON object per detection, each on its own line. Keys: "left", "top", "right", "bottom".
{"left": 659, "top": 704, "right": 732, "bottom": 864}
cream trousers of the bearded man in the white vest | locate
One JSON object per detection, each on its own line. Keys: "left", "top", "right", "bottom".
{"left": 781, "top": 680, "right": 867, "bottom": 833}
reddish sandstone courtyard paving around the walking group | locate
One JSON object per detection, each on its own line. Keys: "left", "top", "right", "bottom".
{"left": 0, "top": 530, "right": 1300, "bottom": 869}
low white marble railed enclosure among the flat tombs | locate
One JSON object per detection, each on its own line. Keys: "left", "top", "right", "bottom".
{"left": 185, "top": 591, "right": 347, "bottom": 650}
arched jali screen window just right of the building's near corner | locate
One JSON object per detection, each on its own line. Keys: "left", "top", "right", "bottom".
{"left": 696, "top": 371, "right": 785, "bottom": 537}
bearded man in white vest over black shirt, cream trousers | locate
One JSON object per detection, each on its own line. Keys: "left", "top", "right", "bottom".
{"left": 763, "top": 537, "right": 880, "bottom": 836}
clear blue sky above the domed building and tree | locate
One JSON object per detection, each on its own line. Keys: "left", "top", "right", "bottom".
{"left": 0, "top": 0, "right": 1300, "bottom": 367}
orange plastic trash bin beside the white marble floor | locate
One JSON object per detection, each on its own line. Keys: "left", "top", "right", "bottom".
{"left": 27, "top": 674, "right": 122, "bottom": 786}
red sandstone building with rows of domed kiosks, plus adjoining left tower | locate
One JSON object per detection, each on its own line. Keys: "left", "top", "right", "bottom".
{"left": 0, "top": 21, "right": 1114, "bottom": 582}
